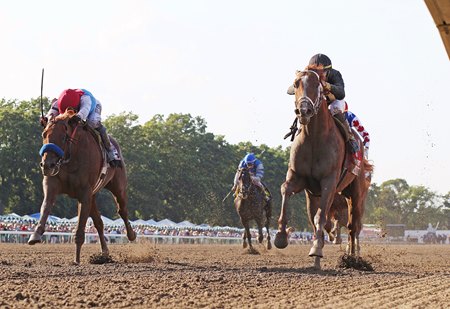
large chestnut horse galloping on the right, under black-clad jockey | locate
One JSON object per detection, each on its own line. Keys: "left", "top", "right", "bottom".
{"left": 275, "top": 67, "right": 372, "bottom": 268}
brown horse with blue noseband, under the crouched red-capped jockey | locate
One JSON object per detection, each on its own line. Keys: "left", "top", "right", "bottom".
{"left": 28, "top": 110, "right": 136, "bottom": 265}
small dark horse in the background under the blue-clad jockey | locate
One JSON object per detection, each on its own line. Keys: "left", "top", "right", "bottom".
{"left": 234, "top": 167, "right": 272, "bottom": 250}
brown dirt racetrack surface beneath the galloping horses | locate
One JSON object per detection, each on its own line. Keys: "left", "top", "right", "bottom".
{"left": 0, "top": 244, "right": 450, "bottom": 308}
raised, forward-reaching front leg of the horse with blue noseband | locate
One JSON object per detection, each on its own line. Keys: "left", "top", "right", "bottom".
{"left": 28, "top": 176, "right": 59, "bottom": 245}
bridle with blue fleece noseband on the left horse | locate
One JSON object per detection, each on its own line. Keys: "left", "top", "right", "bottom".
{"left": 39, "top": 120, "right": 79, "bottom": 176}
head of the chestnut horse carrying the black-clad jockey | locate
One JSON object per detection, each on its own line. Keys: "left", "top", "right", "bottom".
{"left": 294, "top": 68, "right": 325, "bottom": 125}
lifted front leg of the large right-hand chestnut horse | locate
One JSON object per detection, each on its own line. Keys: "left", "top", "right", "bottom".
{"left": 274, "top": 169, "right": 305, "bottom": 249}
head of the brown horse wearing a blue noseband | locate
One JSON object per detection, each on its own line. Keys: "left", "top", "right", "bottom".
{"left": 39, "top": 109, "right": 77, "bottom": 176}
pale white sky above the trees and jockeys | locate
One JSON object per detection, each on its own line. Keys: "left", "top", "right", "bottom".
{"left": 0, "top": 0, "right": 450, "bottom": 194}
